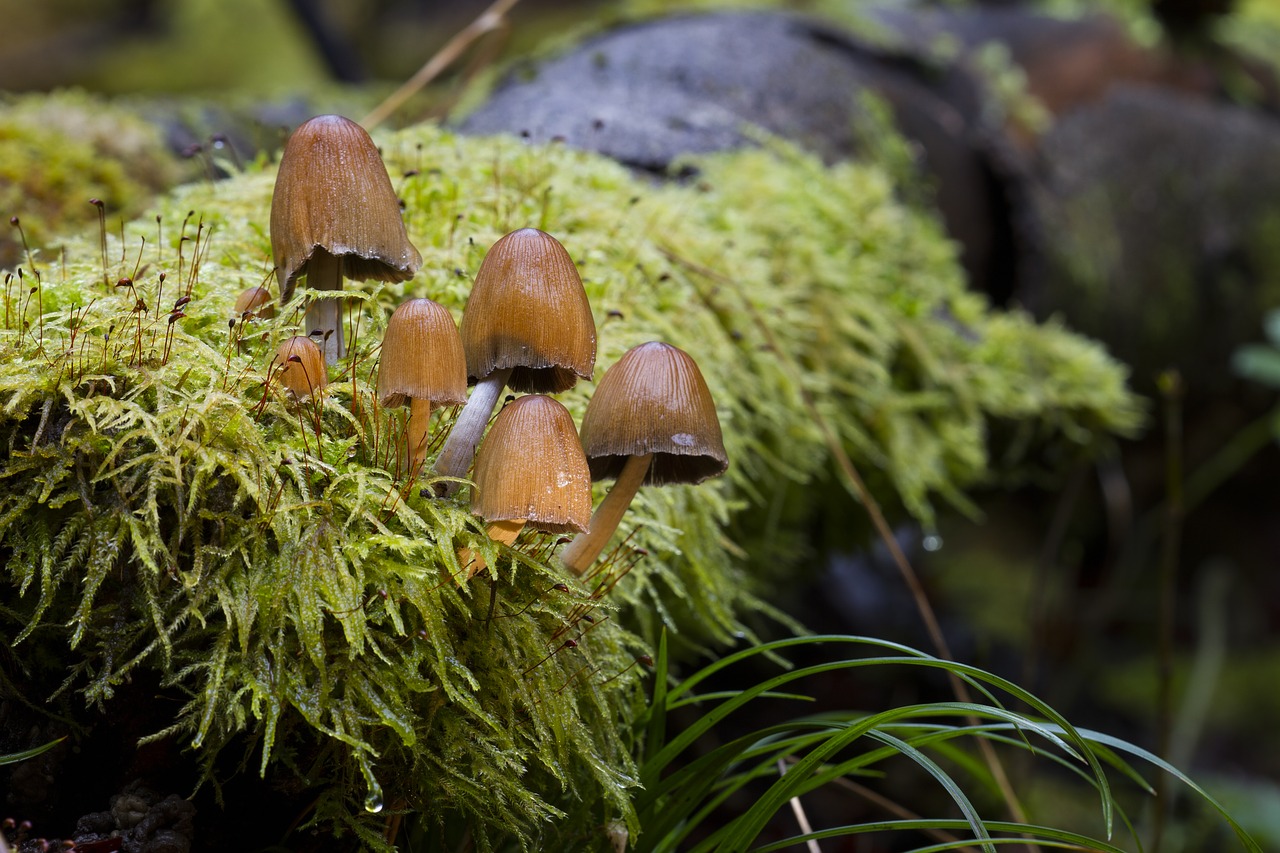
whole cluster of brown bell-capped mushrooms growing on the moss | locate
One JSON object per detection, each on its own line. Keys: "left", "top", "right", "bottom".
{"left": 244, "top": 115, "right": 728, "bottom": 575}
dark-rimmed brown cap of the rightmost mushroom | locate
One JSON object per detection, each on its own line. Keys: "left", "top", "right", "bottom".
{"left": 582, "top": 341, "right": 728, "bottom": 485}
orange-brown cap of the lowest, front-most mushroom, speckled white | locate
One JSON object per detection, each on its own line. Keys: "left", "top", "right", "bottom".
{"left": 471, "top": 394, "right": 591, "bottom": 533}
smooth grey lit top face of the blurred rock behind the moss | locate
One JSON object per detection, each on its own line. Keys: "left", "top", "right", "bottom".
{"left": 462, "top": 14, "right": 952, "bottom": 172}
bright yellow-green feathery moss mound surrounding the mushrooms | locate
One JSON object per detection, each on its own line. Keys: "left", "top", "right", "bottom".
{"left": 0, "top": 116, "right": 1140, "bottom": 849}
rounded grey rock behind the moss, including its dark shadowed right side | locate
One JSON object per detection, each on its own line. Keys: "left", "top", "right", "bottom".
{"left": 460, "top": 13, "right": 1033, "bottom": 300}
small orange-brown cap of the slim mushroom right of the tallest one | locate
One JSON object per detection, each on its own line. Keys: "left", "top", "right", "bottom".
{"left": 378, "top": 298, "right": 467, "bottom": 407}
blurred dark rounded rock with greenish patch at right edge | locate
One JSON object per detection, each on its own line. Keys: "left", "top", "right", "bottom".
{"left": 1028, "top": 86, "right": 1280, "bottom": 392}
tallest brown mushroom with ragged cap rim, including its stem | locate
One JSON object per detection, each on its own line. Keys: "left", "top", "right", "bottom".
{"left": 271, "top": 115, "right": 422, "bottom": 364}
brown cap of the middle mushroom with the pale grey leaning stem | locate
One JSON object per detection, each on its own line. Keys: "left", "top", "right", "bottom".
{"left": 462, "top": 228, "right": 595, "bottom": 393}
